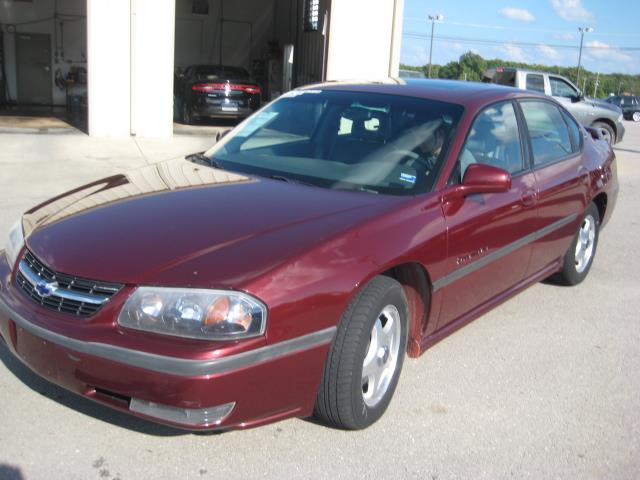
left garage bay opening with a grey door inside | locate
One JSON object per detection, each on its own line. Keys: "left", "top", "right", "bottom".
{"left": 0, "top": 0, "right": 87, "bottom": 132}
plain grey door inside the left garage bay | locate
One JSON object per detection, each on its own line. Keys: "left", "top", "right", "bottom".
{"left": 16, "top": 33, "right": 52, "bottom": 105}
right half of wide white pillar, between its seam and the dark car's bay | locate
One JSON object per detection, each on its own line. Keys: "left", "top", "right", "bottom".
{"left": 131, "top": 0, "right": 176, "bottom": 137}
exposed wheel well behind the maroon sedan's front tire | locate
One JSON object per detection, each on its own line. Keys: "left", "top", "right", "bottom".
{"left": 383, "top": 263, "right": 431, "bottom": 358}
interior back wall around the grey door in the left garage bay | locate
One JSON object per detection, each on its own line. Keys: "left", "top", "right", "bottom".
{"left": 0, "top": 0, "right": 87, "bottom": 105}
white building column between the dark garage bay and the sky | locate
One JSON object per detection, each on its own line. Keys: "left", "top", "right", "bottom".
{"left": 327, "top": 0, "right": 402, "bottom": 80}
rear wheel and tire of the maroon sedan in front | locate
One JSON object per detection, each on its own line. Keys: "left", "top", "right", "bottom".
{"left": 552, "top": 203, "right": 600, "bottom": 286}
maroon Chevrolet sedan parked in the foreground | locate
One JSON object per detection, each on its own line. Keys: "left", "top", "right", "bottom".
{"left": 0, "top": 81, "right": 618, "bottom": 429}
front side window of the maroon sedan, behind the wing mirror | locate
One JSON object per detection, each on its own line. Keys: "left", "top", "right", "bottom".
{"left": 452, "top": 102, "right": 524, "bottom": 183}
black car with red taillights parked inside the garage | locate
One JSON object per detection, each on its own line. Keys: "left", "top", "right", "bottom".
{"left": 174, "top": 65, "right": 262, "bottom": 125}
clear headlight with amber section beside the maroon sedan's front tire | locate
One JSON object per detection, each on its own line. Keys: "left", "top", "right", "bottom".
{"left": 118, "top": 287, "right": 267, "bottom": 340}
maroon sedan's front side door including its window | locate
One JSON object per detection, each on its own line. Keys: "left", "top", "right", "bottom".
{"left": 434, "top": 102, "right": 537, "bottom": 328}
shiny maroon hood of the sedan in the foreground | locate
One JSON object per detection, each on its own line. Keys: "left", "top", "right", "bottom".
{"left": 23, "top": 160, "right": 401, "bottom": 288}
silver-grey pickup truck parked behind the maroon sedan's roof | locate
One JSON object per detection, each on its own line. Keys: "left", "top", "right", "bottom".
{"left": 482, "top": 67, "right": 624, "bottom": 144}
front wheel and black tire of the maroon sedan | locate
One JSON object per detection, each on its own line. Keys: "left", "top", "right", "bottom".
{"left": 315, "top": 276, "right": 408, "bottom": 430}
